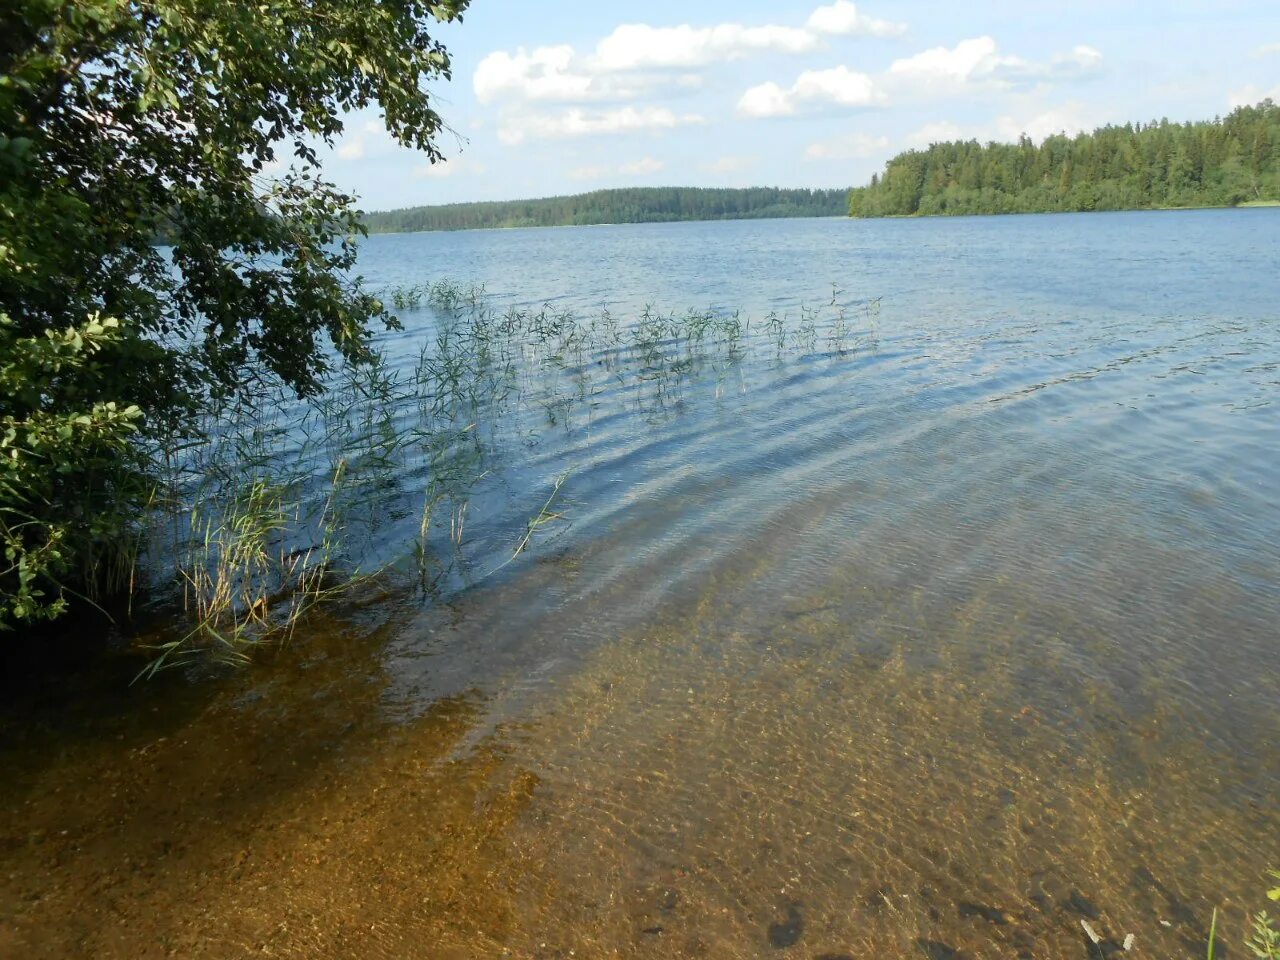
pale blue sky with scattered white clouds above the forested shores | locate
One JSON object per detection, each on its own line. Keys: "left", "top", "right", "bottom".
{"left": 326, "top": 0, "right": 1280, "bottom": 209}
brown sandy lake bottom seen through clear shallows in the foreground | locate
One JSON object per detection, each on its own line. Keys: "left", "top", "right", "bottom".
{"left": 0, "top": 519, "right": 1280, "bottom": 960}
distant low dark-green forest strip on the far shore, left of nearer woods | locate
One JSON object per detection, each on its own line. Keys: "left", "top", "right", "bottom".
{"left": 364, "top": 187, "right": 849, "bottom": 233}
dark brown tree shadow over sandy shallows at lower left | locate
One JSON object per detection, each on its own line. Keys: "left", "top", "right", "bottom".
{"left": 0, "top": 593, "right": 529, "bottom": 957}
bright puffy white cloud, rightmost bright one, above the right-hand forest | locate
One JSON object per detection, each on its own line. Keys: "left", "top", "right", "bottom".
{"left": 888, "top": 37, "right": 1102, "bottom": 95}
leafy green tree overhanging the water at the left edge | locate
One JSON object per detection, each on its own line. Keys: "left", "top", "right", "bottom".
{"left": 0, "top": 0, "right": 467, "bottom": 625}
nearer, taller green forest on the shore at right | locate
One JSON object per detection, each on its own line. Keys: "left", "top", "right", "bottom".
{"left": 849, "top": 100, "right": 1280, "bottom": 216}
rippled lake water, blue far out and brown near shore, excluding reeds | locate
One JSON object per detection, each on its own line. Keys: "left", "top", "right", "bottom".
{"left": 0, "top": 210, "right": 1280, "bottom": 960}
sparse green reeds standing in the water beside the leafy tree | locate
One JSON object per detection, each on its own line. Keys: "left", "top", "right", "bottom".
{"left": 135, "top": 280, "right": 879, "bottom": 673}
